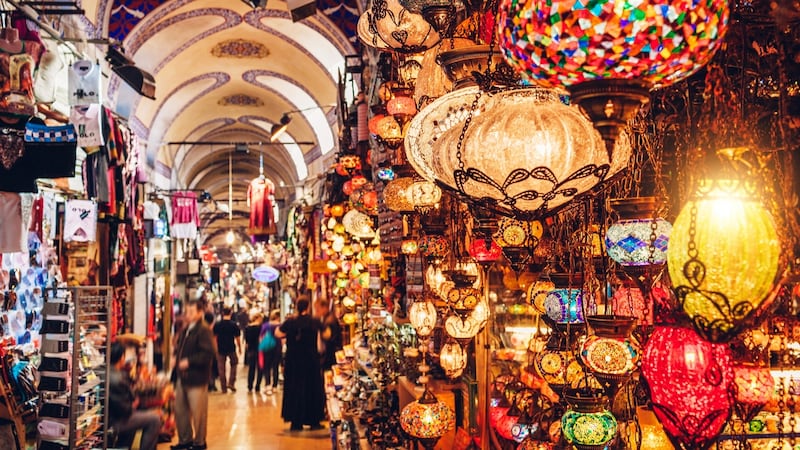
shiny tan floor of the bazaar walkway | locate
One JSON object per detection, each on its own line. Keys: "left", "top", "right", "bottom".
{"left": 158, "top": 370, "right": 331, "bottom": 450}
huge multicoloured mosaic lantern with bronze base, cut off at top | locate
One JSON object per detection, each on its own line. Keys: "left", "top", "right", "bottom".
{"left": 498, "top": 0, "right": 729, "bottom": 156}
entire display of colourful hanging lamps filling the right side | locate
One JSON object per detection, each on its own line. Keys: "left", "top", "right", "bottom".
{"left": 324, "top": 0, "right": 800, "bottom": 450}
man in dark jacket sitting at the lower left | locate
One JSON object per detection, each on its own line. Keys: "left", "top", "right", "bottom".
{"left": 108, "top": 342, "right": 161, "bottom": 450}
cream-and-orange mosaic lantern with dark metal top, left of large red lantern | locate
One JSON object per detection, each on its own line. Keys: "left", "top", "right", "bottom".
{"left": 580, "top": 316, "right": 641, "bottom": 402}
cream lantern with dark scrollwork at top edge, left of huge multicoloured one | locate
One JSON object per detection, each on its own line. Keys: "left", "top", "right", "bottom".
{"left": 357, "top": 0, "right": 441, "bottom": 53}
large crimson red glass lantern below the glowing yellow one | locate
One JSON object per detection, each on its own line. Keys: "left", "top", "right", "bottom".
{"left": 642, "top": 326, "right": 733, "bottom": 448}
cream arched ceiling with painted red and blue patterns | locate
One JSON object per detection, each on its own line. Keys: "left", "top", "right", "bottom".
{"left": 82, "top": 0, "right": 359, "bottom": 250}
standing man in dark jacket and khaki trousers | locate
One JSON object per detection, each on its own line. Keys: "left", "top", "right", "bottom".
{"left": 172, "top": 301, "right": 216, "bottom": 450}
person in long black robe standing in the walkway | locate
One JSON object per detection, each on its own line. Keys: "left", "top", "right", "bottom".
{"left": 275, "top": 297, "right": 325, "bottom": 431}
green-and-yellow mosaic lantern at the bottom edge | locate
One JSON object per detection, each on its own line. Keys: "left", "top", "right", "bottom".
{"left": 561, "top": 391, "right": 617, "bottom": 450}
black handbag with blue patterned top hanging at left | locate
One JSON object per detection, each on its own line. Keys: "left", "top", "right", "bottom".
{"left": 25, "top": 122, "right": 78, "bottom": 178}
